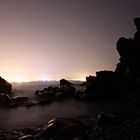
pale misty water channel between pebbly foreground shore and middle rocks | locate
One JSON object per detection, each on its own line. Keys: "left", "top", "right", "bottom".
{"left": 0, "top": 99, "right": 94, "bottom": 129}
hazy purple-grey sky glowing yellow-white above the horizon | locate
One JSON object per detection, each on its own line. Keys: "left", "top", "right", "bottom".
{"left": 0, "top": 0, "right": 140, "bottom": 81}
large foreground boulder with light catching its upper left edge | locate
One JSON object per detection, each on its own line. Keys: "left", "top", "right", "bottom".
{"left": 41, "top": 118, "right": 86, "bottom": 139}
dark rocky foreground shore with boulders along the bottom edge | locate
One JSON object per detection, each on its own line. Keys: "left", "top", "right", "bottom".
{"left": 0, "top": 112, "right": 140, "bottom": 140}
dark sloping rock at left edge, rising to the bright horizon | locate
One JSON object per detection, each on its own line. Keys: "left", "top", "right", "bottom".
{"left": 0, "top": 77, "right": 12, "bottom": 94}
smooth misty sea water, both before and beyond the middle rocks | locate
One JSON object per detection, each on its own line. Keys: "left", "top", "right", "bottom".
{"left": 0, "top": 82, "right": 131, "bottom": 130}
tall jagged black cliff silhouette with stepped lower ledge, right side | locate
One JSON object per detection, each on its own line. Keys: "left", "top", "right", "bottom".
{"left": 84, "top": 18, "right": 140, "bottom": 100}
